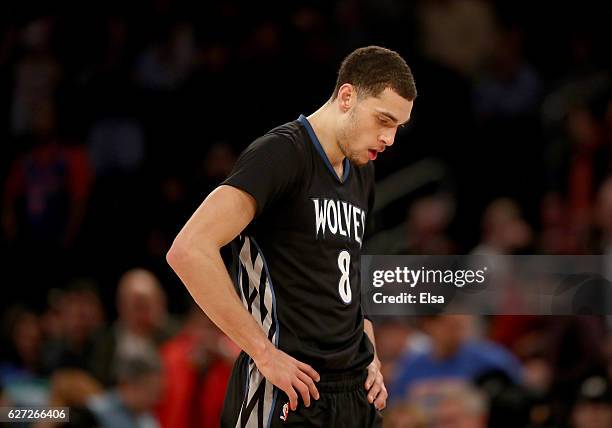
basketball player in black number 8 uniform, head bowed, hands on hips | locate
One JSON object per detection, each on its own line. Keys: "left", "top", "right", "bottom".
{"left": 167, "top": 46, "right": 416, "bottom": 427}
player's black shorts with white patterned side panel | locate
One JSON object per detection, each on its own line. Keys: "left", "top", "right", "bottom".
{"left": 221, "top": 352, "right": 382, "bottom": 428}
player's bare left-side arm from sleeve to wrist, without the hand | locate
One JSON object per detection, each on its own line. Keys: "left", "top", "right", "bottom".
{"left": 167, "top": 186, "right": 272, "bottom": 359}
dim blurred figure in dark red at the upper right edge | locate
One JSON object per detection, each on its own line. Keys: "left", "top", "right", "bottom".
{"left": 542, "top": 67, "right": 612, "bottom": 241}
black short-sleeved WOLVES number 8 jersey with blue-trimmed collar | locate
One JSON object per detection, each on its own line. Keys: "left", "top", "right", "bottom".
{"left": 223, "top": 116, "right": 374, "bottom": 373}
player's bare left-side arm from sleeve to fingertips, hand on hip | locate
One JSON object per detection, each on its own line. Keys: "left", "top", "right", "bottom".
{"left": 166, "top": 186, "right": 320, "bottom": 410}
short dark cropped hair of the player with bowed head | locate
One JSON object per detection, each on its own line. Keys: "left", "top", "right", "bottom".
{"left": 332, "top": 46, "right": 417, "bottom": 101}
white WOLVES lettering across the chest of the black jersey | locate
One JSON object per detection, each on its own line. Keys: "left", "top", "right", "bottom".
{"left": 311, "top": 198, "right": 366, "bottom": 247}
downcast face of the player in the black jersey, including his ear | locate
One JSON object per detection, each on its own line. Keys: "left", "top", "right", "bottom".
{"left": 337, "top": 84, "right": 413, "bottom": 166}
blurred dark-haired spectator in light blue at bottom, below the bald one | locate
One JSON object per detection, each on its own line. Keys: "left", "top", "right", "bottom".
{"left": 87, "top": 351, "right": 163, "bottom": 428}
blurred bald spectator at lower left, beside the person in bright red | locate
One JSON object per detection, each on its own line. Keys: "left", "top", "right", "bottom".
{"left": 91, "top": 269, "right": 178, "bottom": 385}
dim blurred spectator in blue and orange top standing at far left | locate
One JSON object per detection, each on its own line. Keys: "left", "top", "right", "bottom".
{"left": 2, "top": 99, "right": 92, "bottom": 249}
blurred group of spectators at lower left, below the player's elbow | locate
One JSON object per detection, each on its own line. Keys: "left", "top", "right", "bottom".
{"left": 0, "top": 268, "right": 239, "bottom": 428}
